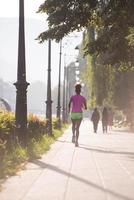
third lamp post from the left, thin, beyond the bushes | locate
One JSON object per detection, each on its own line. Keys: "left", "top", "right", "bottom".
{"left": 57, "top": 40, "right": 62, "bottom": 128}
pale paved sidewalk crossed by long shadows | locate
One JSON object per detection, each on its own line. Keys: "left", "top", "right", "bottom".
{"left": 0, "top": 120, "right": 134, "bottom": 200}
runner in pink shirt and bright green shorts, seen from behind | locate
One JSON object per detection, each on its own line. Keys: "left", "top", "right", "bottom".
{"left": 69, "top": 84, "right": 87, "bottom": 146}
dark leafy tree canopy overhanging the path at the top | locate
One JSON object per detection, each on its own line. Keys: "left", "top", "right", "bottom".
{"left": 38, "top": 0, "right": 134, "bottom": 67}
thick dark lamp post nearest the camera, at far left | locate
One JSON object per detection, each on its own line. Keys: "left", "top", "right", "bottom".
{"left": 14, "top": 0, "right": 29, "bottom": 145}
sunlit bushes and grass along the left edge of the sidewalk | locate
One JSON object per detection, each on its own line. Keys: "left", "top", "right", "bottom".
{"left": 0, "top": 112, "right": 66, "bottom": 178}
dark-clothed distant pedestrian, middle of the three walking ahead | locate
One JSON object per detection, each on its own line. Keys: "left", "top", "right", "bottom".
{"left": 102, "top": 107, "right": 108, "bottom": 133}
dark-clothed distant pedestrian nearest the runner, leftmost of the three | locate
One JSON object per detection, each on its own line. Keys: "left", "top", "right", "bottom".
{"left": 91, "top": 108, "right": 100, "bottom": 133}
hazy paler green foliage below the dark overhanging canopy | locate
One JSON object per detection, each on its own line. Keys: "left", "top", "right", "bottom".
{"left": 83, "top": 19, "right": 134, "bottom": 126}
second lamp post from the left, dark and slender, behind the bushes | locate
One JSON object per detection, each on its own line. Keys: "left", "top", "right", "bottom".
{"left": 46, "top": 40, "right": 52, "bottom": 135}
